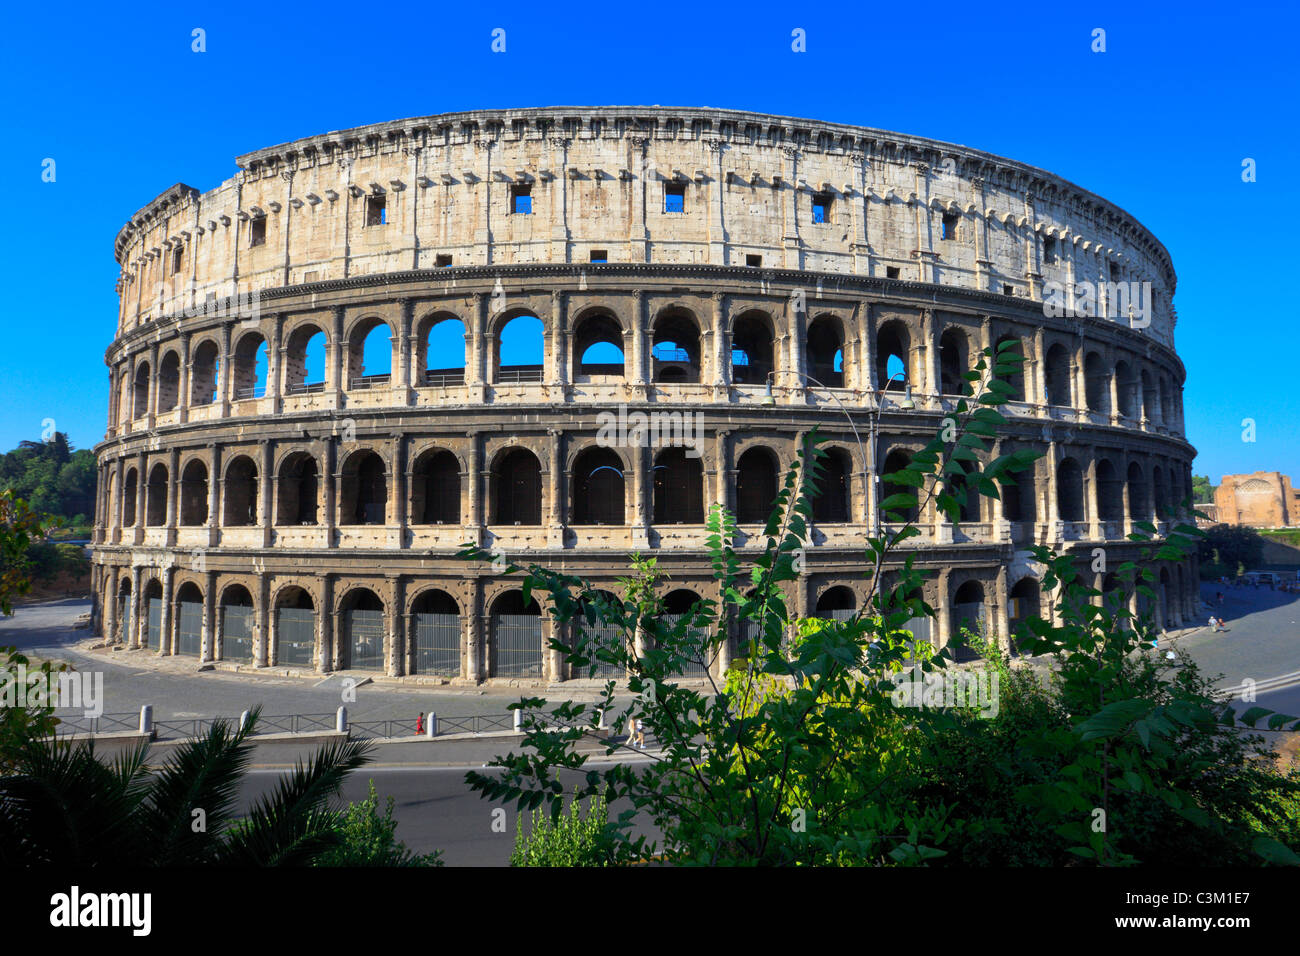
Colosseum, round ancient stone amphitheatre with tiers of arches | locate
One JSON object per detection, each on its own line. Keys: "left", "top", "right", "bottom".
{"left": 86, "top": 107, "right": 1196, "bottom": 683}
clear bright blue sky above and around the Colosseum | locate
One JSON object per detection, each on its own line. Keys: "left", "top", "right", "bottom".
{"left": 0, "top": 0, "right": 1300, "bottom": 483}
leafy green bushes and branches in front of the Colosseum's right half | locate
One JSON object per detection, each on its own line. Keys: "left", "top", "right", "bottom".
{"left": 463, "top": 346, "right": 1300, "bottom": 865}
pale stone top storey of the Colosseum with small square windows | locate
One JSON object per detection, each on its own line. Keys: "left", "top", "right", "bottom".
{"left": 116, "top": 108, "right": 1175, "bottom": 346}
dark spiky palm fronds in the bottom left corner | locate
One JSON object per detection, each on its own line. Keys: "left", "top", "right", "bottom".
{"left": 0, "top": 710, "right": 369, "bottom": 866}
